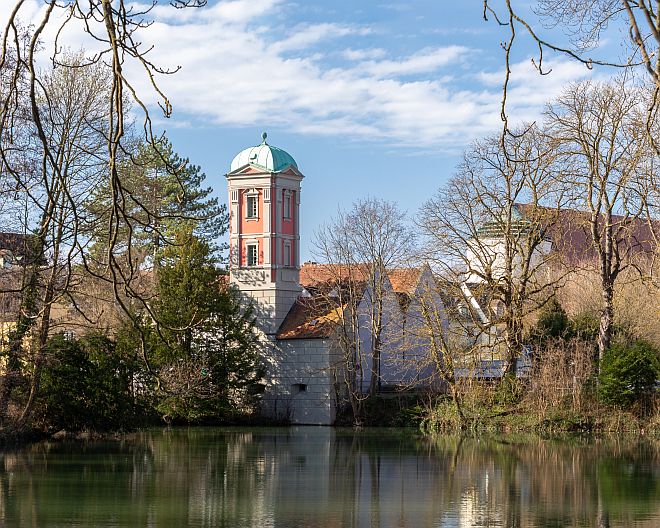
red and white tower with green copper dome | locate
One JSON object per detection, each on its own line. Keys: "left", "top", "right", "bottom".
{"left": 226, "top": 133, "right": 304, "bottom": 335}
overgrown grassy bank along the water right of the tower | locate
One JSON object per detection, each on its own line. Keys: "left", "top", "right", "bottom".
{"left": 336, "top": 385, "right": 660, "bottom": 438}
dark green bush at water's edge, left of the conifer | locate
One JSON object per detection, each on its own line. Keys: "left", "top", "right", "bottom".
{"left": 39, "top": 334, "right": 139, "bottom": 432}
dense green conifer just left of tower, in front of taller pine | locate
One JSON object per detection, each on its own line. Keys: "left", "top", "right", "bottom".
{"left": 151, "top": 226, "right": 262, "bottom": 422}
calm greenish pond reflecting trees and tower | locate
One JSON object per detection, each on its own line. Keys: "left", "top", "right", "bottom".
{"left": 0, "top": 427, "right": 660, "bottom": 528}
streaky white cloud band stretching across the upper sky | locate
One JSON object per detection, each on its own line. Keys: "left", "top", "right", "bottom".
{"left": 0, "top": 0, "right": 600, "bottom": 150}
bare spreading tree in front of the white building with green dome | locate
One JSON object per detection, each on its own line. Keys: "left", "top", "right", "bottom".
{"left": 417, "top": 127, "right": 563, "bottom": 375}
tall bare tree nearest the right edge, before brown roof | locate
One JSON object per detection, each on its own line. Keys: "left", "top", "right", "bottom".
{"left": 547, "top": 82, "right": 658, "bottom": 368}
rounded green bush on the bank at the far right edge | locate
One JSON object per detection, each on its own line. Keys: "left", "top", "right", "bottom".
{"left": 598, "top": 340, "right": 660, "bottom": 406}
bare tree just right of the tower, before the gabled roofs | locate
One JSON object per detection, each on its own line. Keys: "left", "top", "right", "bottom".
{"left": 314, "top": 198, "right": 414, "bottom": 419}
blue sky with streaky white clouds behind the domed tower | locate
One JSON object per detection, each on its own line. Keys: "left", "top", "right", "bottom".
{"left": 9, "top": 0, "right": 620, "bottom": 260}
